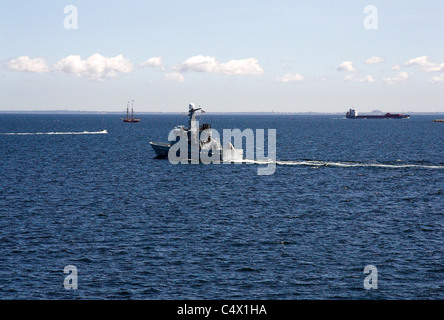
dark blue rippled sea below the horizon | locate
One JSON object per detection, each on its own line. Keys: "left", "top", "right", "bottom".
{"left": 0, "top": 114, "right": 444, "bottom": 300}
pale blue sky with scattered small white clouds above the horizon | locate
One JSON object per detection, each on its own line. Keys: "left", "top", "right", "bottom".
{"left": 0, "top": 0, "right": 444, "bottom": 112}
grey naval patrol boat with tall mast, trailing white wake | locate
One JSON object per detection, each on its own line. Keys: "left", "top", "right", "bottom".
{"left": 150, "top": 103, "right": 244, "bottom": 162}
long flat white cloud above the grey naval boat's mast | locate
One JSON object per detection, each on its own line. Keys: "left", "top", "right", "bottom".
{"left": 173, "top": 55, "right": 264, "bottom": 75}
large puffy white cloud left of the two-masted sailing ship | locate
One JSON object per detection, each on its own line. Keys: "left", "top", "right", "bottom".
{"left": 54, "top": 53, "right": 134, "bottom": 81}
